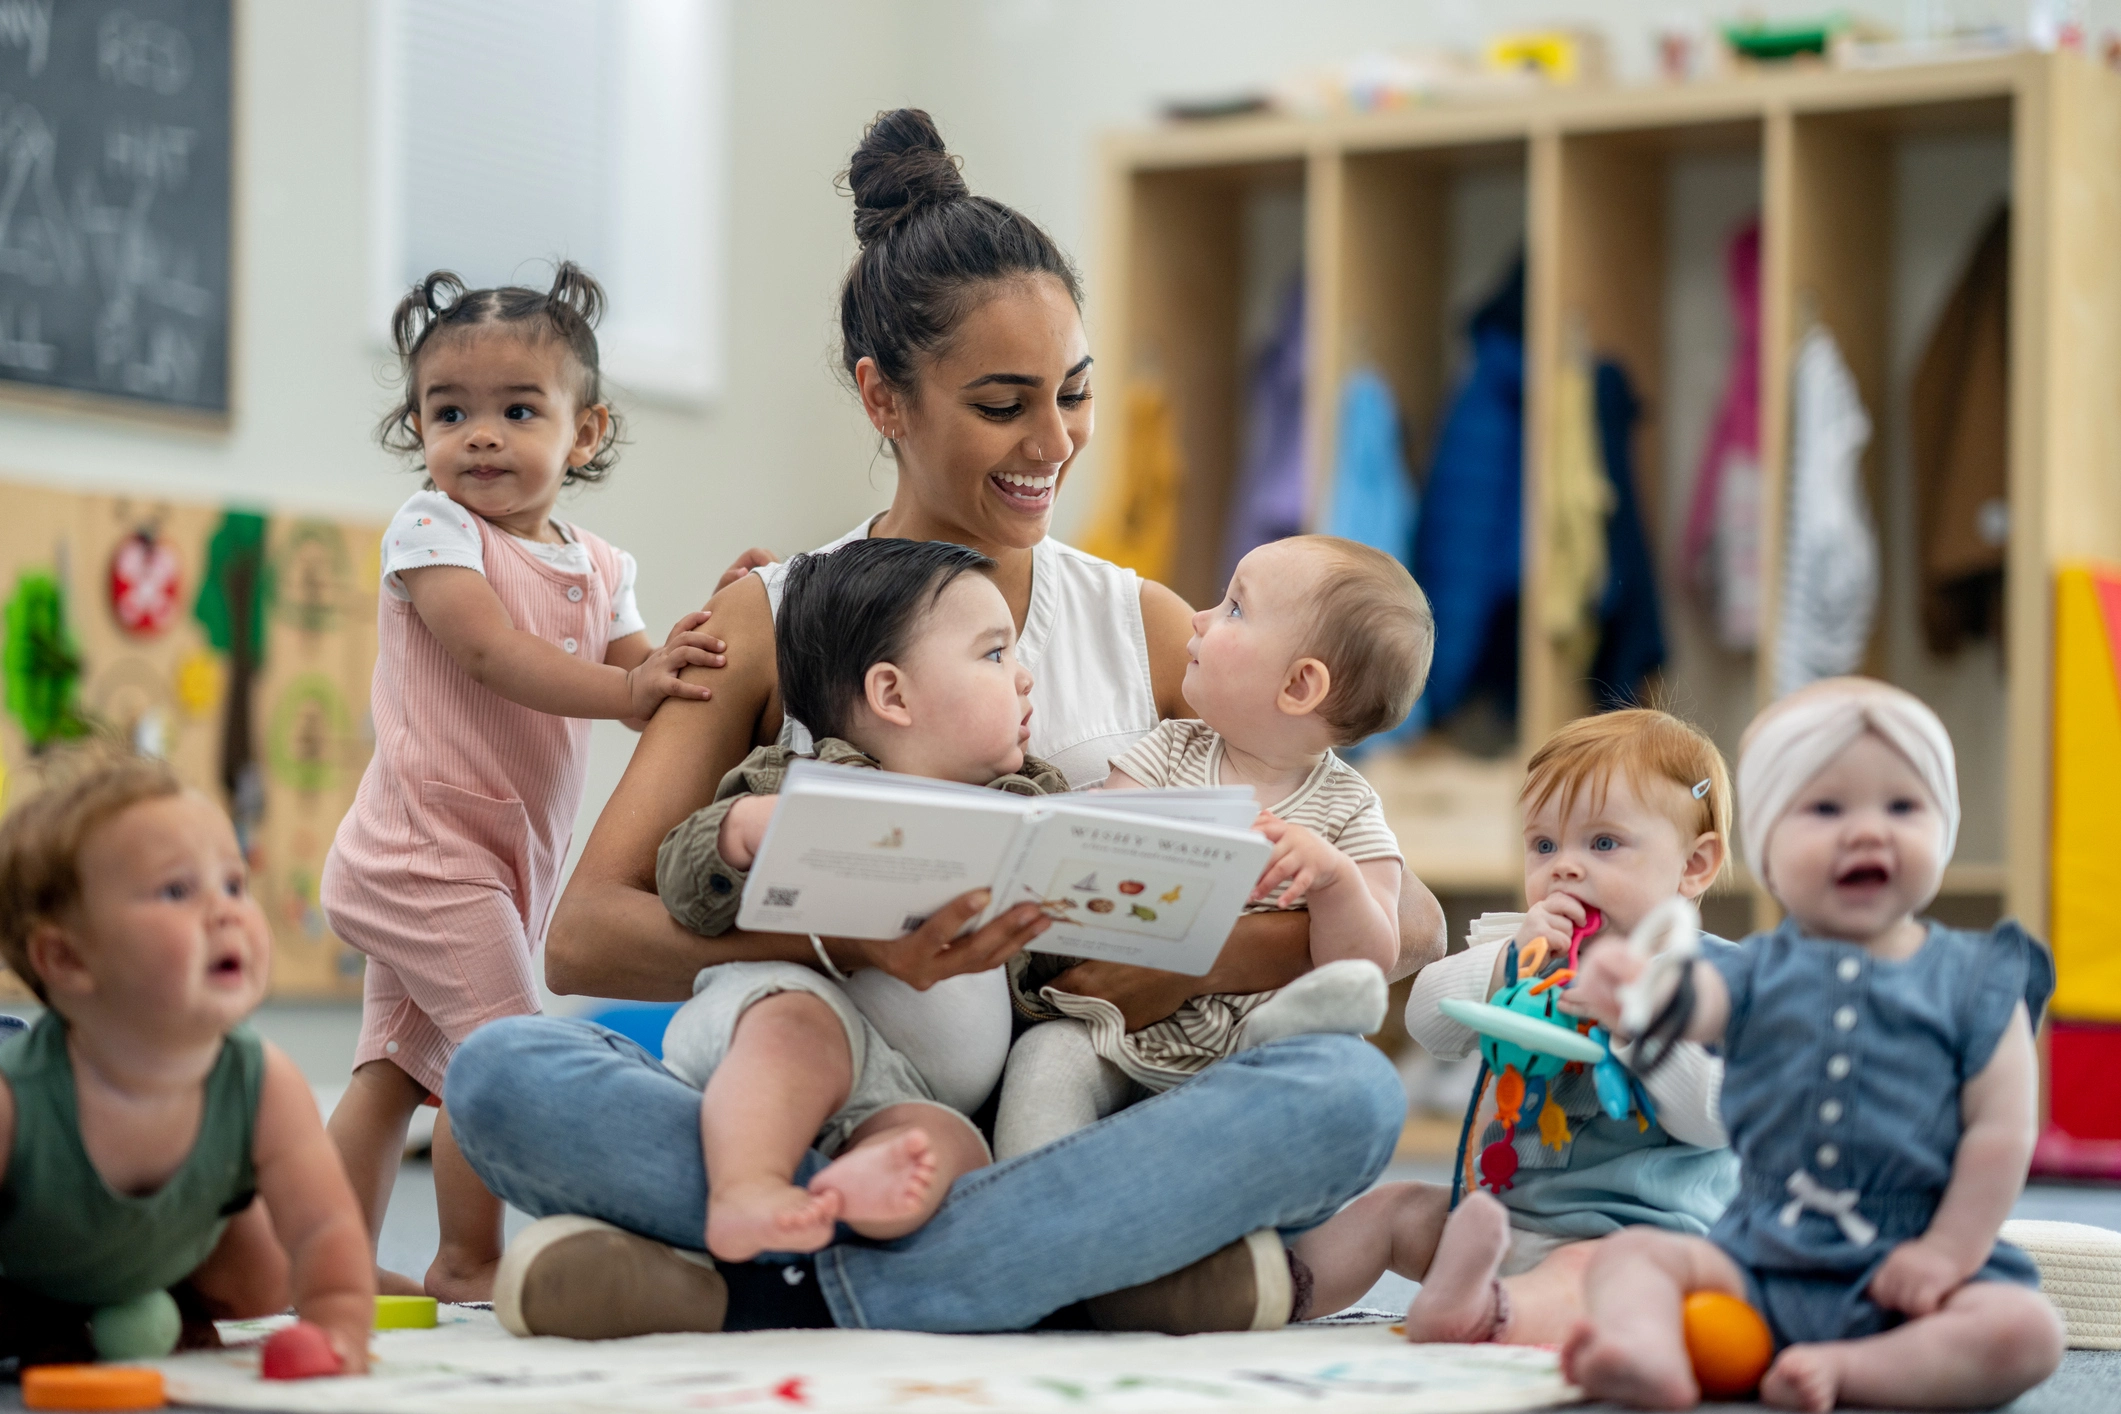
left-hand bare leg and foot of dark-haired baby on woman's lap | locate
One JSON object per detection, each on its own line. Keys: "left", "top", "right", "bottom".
{"left": 700, "top": 992, "right": 855, "bottom": 1261}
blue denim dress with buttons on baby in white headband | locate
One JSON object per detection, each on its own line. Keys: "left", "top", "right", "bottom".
{"left": 1707, "top": 920, "right": 2055, "bottom": 1346}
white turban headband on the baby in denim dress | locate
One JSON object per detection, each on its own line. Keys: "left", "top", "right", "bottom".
{"left": 1737, "top": 678, "right": 1960, "bottom": 890}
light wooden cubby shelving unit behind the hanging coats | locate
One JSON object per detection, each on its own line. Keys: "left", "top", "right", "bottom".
{"left": 1092, "top": 53, "right": 2121, "bottom": 931}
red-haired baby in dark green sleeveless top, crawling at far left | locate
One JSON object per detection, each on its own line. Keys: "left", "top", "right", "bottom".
{"left": 0, "top": 759, "right": 375, "bottom": 1372}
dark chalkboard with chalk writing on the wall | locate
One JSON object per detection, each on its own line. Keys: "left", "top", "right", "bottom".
{"left": 0, "top": 0, "right": 231, "bottom": 411}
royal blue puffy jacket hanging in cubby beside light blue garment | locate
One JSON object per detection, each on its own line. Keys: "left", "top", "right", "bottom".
{"left": 1413, "top": 259, "right": 1525, "bottom": 723}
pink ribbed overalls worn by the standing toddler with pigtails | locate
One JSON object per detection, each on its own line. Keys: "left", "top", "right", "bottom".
{"left": 320, "top": 515, "right": 619, "bottom": 1096}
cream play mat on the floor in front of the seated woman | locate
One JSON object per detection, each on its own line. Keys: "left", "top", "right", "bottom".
{"left": 159, "top": 1306, "right": 1578, "bottom": 1414}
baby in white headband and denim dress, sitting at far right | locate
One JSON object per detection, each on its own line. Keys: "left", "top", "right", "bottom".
{"left": 1561, "top": 678, "right": 2064, "bottom": 1410}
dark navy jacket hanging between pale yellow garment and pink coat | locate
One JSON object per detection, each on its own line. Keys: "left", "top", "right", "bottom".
{"left": 1591, "top": 363, "right": 1665, "bottom": 708}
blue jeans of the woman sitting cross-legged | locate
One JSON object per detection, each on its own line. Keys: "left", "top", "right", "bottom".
{"left": 443, "top": 1015, "right": 1406, "bottom": 1331}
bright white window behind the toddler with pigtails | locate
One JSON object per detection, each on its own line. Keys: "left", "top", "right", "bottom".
{"left": 371, "top": 0, "right": 728, "bottom": 403}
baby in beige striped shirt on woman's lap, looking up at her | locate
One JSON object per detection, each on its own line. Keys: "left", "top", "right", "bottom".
{"left": 995, "top": 534, "right": 1436, "bottom": 1157}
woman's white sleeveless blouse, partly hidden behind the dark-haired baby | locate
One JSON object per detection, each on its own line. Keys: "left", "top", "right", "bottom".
{"left": 753, "top": 522, "right": 1158, "bottom": 791}
